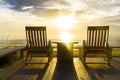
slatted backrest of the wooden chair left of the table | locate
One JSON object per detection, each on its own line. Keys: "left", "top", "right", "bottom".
{"left": 25, "top": 26, "right": 47, "bottom": 48}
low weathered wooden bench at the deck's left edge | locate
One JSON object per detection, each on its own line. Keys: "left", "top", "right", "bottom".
{"left": 0, "top": 46, "right": 25, "bottom": 67}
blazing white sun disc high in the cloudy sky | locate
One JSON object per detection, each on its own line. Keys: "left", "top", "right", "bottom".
{"left": 55, "top": 15, "right": 76, "bottom": 29}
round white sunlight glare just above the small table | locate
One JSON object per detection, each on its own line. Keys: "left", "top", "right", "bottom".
{"left": 59, "top": 32, "right": 73, "bottom": 43}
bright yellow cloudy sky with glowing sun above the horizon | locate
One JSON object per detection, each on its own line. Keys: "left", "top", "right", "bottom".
{"left": 0, "top": 0, "right": 120, "bottom": 40}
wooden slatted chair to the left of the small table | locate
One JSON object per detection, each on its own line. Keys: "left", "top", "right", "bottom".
{"left": 25, "top": 26, "right": 51, "bottom": 64}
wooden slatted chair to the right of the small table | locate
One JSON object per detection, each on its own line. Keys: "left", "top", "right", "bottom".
{"left": 83, "top": 26, "right": 110, "bottom": 64}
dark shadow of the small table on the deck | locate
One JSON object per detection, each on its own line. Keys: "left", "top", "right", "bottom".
{"left": 52, "top": 63, "right": 78, "bottom": 80}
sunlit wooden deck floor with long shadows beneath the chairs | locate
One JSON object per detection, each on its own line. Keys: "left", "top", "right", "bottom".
{"left": 0, "top": 58, "right": 120, "bottom": 80}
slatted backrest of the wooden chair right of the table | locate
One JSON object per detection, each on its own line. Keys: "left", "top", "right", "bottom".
{"left": 87, "top": 26, "right": 109, "bottom": 47}
